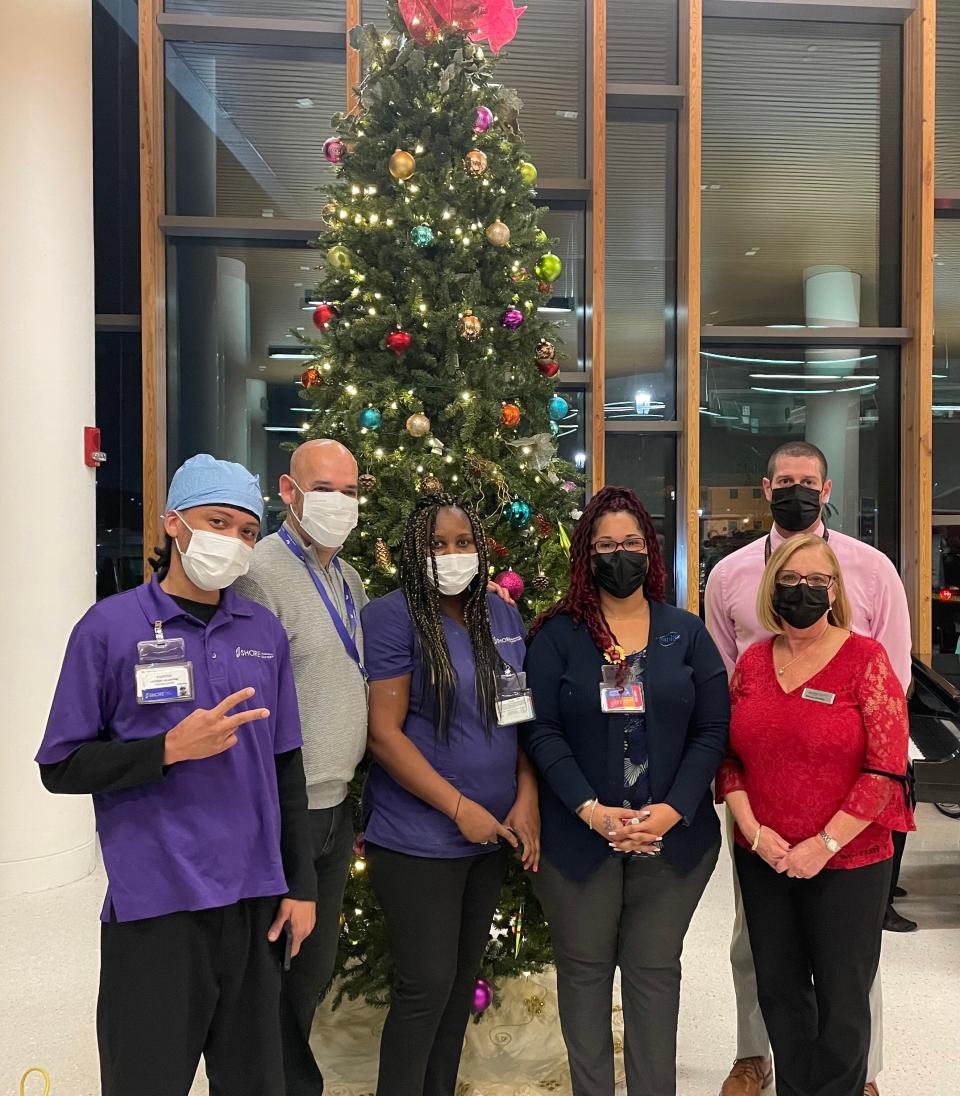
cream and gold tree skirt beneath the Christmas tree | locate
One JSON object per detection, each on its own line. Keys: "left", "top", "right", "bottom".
{"left": 311, "top": 970, "right": 626, "bottom": 1096}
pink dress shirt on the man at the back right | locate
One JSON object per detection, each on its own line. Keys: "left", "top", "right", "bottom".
{"left": 704, "top": 525, "right": 911, "bottom": 690}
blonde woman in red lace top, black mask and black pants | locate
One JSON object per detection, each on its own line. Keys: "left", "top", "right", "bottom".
{"left": 717, "top": 536, "right": 914, "bottom": 1096}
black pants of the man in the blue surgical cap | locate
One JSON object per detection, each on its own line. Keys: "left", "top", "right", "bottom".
{"left": 96, "top": 898, "right": 284, "bottom": 1096}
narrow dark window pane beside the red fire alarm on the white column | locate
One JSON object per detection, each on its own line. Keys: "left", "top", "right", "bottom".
{"left": 96, "top": 332, "right": 144, "bottom": 598}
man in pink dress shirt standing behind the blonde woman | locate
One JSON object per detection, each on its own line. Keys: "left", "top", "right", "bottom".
{"left": 705, "top": 442, "right": 916, "bottom": 1096}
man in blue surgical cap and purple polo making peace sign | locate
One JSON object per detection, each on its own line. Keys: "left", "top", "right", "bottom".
{"left": 36, "top": 454, "right": 317, "bottom": 1096}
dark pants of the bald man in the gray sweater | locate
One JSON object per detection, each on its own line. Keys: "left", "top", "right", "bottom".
{"left": 281, "top": 800, "right": 353, "bottom": 1096}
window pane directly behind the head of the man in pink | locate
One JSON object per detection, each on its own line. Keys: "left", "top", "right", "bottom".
{"left": 700, "top": 345, "right": 900, "bottom": 594}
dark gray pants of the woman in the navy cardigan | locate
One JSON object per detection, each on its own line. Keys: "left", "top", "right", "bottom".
{"left": 534, "top": 842, "right": 719, "bottom": 1096}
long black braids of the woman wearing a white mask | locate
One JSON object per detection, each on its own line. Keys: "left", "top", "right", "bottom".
{"left": 400, "top": 494, "right": 501, "bottom": 742}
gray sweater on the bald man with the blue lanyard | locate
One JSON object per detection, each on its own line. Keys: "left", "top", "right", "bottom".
{"left": 233, "top": 523, "right": 367, "bottom": 810}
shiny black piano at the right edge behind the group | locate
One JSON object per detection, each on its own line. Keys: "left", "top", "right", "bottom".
{"left": 908, "top": 658, "right": 960, "bottom": 819}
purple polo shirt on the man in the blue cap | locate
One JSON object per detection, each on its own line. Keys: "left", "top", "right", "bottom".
{"left": 36, "top": 579, "right": 301, "bottom": 921}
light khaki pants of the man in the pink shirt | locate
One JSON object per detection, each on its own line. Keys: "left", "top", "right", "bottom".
{"left": 725, "top": 810, "right": 883, "bottom": 1081}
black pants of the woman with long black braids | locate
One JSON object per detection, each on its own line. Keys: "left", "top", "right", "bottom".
{"left": 367, "top": 844, "right": 506, "bottom": 1096}
